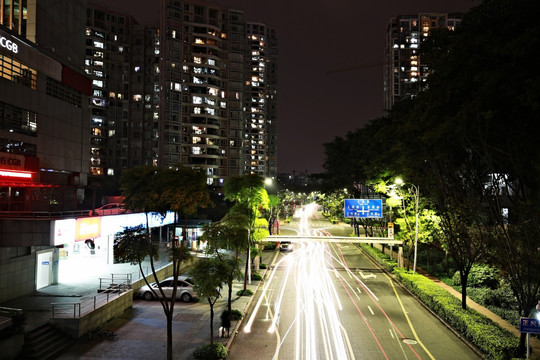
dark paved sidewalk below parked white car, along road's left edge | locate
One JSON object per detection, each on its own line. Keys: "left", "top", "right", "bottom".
{"left": 54, "top": 251, "right": 276, "bottom": 360}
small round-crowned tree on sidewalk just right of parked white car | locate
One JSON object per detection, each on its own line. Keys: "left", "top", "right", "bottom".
{"left": 189, "top": 257, "right": 229, "bottom": 344}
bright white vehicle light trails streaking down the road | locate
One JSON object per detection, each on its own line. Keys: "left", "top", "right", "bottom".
{"left": 244, "top": 206, "right": 355, "bottom": 360}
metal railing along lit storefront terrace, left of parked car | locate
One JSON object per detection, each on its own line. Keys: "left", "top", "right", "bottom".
{"left": 51, "top": 274, "right": 131, "bottom": 319}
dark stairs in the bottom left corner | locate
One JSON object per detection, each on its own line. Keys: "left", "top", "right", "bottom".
{"left": 17, "top": 323, "right": 75, "bottom": 360}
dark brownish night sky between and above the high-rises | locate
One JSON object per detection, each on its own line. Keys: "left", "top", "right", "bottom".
{"left": 114, "top": 0, "right": 479, "bottom": 174}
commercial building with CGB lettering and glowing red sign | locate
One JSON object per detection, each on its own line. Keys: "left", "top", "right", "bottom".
{"left": 0, "top": 0, "right": 91, "bottom": 299}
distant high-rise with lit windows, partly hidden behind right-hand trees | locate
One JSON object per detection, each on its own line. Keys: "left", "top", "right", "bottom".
{"left": 384, "top": 13, "right": 461, "bottom": 110}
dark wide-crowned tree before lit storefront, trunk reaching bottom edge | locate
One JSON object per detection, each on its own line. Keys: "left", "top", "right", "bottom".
{"left": 120, "top": 166, "right": 209, "bottom": 360}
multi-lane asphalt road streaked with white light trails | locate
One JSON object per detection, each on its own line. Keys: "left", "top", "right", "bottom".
{"left": 229, "top": 206, "right": 480, "bottom": 360}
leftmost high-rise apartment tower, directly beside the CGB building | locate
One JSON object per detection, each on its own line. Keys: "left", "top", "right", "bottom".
{"left": 84, "top": 2, "right": 136, "bottom": 176}
